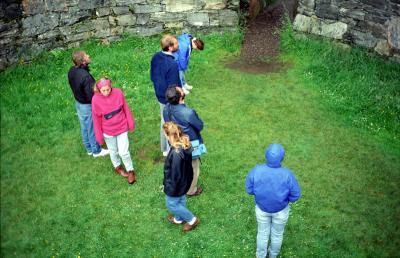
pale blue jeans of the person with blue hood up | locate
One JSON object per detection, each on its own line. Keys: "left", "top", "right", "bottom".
{"left": 256, "top": 205, "right": 289, "bottom": 258}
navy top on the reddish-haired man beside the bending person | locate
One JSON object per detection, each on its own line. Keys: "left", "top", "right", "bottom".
{"left": 150, "top": 52, "right": 182, "bottom": 104}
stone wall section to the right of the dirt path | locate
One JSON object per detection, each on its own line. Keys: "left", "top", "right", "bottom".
{"left": 294, "top": 0, "right": 400, "bottom": 61}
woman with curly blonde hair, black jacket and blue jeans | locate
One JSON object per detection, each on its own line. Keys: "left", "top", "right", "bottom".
{"left": 163, "top": 122, "right": 200, "bottom": 232}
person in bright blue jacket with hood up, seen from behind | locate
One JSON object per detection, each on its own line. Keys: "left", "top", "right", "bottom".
{"left": 246, "top": 144, "right": 301, "bottom": 258}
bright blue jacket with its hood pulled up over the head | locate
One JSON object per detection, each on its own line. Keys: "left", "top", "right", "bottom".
{"left": 246, "top": 144, "right": 300, "bottom": 213}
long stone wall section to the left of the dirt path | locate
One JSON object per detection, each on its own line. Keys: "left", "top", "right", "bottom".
{"left": 0, "top": 0, "right": 239, "bottom": 70}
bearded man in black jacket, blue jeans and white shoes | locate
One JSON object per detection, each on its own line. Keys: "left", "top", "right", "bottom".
{"left": 68, "top": 51, "right": 110, "bottom": 158}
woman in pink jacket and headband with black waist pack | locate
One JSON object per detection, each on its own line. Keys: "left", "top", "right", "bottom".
{"left": 92, "top": 78, "right": 136, "bottom": 184}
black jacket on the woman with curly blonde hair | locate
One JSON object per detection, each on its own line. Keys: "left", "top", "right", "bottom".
{"left": 164, "top": 146, "right": 193, "bottom": 197}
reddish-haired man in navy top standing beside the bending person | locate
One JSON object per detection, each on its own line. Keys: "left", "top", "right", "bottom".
{"left": 150, "top": 34, "right": 181, "bottom": 156}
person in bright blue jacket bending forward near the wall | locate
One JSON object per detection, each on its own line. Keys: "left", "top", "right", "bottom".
{"left": 174, "top": 33, "right": 204, "bottom": 94}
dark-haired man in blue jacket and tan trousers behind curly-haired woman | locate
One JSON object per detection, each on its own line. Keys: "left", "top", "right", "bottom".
{"left": 163, "top": 87, "right": 204, "bottom": 197}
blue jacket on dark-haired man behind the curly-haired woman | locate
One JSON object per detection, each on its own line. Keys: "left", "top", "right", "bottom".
{"left": 163, "top": 103, "right": 204, "bottom": 143}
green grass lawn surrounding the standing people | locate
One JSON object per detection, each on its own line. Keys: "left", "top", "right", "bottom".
{"left": 0, "top": 26, "right": 400, "bottom": 257}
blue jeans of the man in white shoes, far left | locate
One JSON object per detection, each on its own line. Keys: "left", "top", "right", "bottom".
{"left": 75, "top": 101, "right": 101, "bottom": 154}
